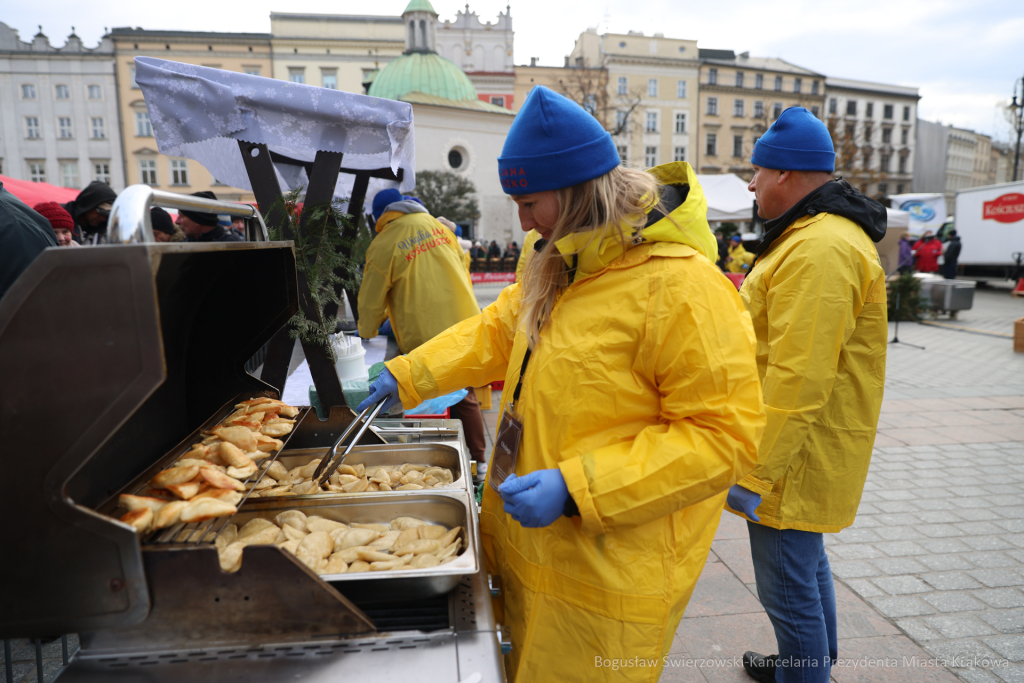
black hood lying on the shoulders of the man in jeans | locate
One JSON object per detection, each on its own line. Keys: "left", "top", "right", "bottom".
{"left": 751, "top": 178, "right": 888, "bottom": 268}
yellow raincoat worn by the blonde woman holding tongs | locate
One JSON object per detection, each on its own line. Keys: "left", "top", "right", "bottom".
{"left": 387, "top": 163, "right": 764, "bottom": 683}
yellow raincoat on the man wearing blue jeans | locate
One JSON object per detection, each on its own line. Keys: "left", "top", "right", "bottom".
{"left": 737, "top": 192, "right": 888, "bottom": 533}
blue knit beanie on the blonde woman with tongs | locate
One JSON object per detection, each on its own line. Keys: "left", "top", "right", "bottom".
{"left": 498, "top": 85, "right": 620, "bottom": 195}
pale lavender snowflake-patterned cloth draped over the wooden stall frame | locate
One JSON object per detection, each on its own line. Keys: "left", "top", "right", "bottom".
{"left": 135, "top": 57, "right": 416, "bottom": 193}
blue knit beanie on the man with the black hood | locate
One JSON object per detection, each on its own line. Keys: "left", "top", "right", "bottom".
{"left": 751, "top": 106, "right": 836, "bottom": 173}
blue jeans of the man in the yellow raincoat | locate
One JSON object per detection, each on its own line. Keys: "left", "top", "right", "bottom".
{"left": 746, "top": 522, "right": 839, "bottom": 683}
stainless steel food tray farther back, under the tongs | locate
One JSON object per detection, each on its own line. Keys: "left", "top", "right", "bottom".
{"left": 247, "top": 442, "right": 472, "bottom": 505}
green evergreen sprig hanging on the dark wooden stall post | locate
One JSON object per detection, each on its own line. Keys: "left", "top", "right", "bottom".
{"left": 267, "top": 187, "right": 360, "bottom": 361}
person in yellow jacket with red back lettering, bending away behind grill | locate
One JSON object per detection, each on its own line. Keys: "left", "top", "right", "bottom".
{"left": 358, "top": 189, "right": 486, "bottom": 471}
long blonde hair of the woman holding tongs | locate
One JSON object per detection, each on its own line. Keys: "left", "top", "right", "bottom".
{"left": 519, "top": 166, "right": 660, "bottom": 348}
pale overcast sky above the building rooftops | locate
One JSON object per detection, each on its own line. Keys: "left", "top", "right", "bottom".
{"left": 8, "top": 0, "right": 1024, "bottom": 139}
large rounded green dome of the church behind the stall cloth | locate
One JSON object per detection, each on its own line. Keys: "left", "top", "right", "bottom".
{"left": 368, "top": 52, "right": 476, "bottom": 101}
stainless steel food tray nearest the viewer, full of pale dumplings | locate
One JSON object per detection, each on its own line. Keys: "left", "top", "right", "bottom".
{"left": 230, "top": 490, "right": 480, "bottom": 601}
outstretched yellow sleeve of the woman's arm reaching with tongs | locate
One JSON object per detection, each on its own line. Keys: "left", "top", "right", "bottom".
{"left": 384, "top": 285, "right": 519, "bottom": 408}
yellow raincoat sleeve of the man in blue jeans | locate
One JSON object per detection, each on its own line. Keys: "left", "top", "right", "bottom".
{"left": 739, "top": 234, "right": 864, "bottom": 496}
